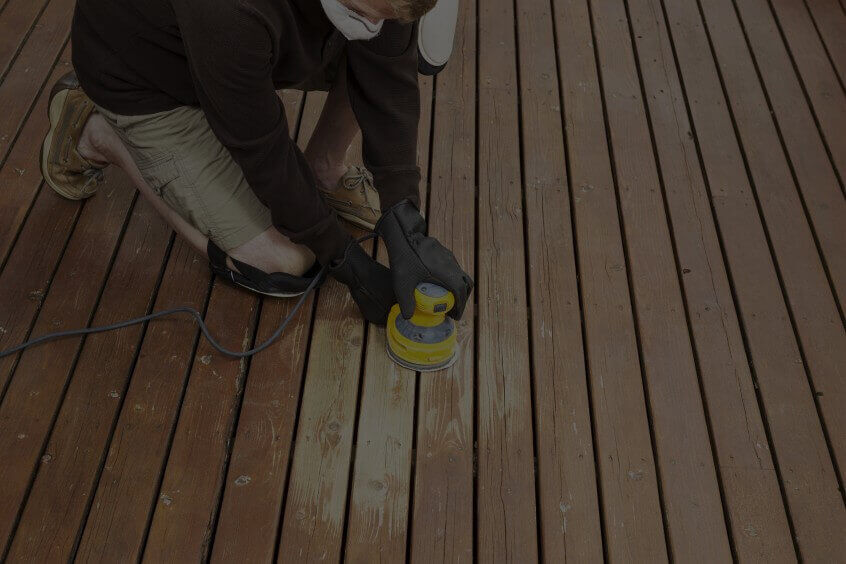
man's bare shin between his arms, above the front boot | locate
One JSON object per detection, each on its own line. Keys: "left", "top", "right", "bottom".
{"left": 304, "top": 68, "right": 359, "bottom": 191}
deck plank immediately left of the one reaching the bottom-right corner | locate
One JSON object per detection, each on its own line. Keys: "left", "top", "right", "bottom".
{"left": 628, "top": 0, "right": 795, "bottom": 562}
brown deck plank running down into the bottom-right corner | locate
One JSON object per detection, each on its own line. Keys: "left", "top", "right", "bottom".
{"left": 665, "top": 1, "right": 846, "bottom": 560}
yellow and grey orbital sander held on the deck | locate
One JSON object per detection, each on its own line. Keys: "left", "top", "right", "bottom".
{"left": 387, "top": 283, "right": 458, "bottom": 372}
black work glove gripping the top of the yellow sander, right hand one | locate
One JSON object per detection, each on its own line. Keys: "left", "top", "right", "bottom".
{"left": 376, "top": 200, "right": 473, "bottom": 319}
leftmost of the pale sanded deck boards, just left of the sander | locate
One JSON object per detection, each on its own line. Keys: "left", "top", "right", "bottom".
{"left": 277, "top": 92, "right": 372, "bottom": 562}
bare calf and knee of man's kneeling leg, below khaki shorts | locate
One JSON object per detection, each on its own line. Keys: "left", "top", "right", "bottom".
{"left": 77, "top": 113, "right": 314, "bottom": 276}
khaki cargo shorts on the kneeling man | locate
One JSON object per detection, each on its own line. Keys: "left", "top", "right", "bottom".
{"left": 97, "top": 106, "right": 272, "bottom": 251}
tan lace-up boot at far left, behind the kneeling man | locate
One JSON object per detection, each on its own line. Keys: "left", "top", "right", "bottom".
{"left": 41, "top": 72, "right": 103, "bottom": 200}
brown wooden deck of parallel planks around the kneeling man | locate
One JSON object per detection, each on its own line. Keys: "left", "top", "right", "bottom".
{"left": 0, "top": 0, "right": 846, "bottom": 563}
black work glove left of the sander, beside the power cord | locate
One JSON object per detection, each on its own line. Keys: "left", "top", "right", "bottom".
{"left": 329, "top": 241, "right": 396, "bottom": 325}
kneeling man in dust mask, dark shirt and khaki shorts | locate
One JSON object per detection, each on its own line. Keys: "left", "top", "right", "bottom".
{"left": 42, "top": 0, "right": 473, "bottom": 324}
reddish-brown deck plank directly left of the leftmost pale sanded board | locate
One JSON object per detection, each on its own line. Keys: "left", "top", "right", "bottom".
{"left": 211, "top": 91, "right": 314, "bottom": 562}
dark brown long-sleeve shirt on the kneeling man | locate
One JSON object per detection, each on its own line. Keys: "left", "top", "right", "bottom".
{"left": 73, "top": 0, "right": 420, "bottom": 263}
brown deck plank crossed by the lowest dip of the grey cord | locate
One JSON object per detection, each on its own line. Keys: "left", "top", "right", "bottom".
{"left": 143, "top": 278, "right": 259, "bottom": 562}
